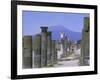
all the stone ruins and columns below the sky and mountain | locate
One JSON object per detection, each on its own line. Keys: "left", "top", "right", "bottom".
{"left": 22, "top": 17, "right": 90, "bottom": 68}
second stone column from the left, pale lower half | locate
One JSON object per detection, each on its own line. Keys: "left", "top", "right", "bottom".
{"left": 32, "top": 34, "right": 41, "bottom": 68}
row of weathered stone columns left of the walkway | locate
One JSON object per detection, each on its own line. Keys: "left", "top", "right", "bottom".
{"left": 23, "top": 27, "right": 57, "bottom": 68}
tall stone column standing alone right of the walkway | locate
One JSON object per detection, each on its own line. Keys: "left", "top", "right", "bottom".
{"left": 80, "top": 17, "right": 90, "bottom": 65}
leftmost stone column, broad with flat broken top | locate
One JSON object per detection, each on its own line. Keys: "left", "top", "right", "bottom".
{"left": 22, "top": 36, "right": 32, "bottom": 68}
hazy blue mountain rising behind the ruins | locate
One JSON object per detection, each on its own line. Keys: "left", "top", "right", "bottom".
{"left": 48, "top": 25, "right": 82, "bottom": 41}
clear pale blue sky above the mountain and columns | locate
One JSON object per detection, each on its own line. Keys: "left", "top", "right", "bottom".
{"left": 22, "top": 11, "right": 89, "bottom": 35}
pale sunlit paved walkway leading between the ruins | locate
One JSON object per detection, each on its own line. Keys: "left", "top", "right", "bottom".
{"left": 54, "top": 49, "right": 80, "bottom": 67}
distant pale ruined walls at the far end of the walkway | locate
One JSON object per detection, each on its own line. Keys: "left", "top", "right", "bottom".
{"left": 57, "top": 32, "right": 76, "bottom": 59}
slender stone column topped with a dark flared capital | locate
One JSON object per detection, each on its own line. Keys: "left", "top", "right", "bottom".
{"left": 41, "top": 27, "right": 48, "bottom": 67}
